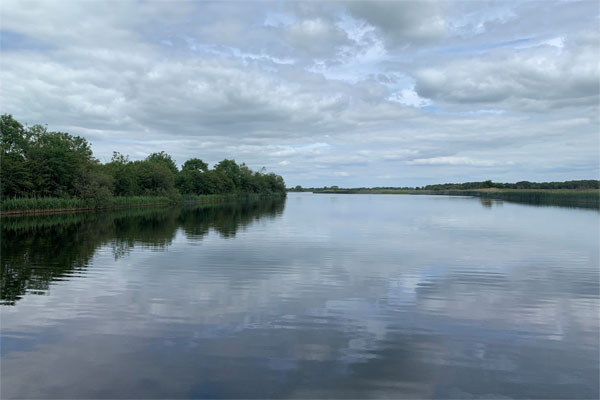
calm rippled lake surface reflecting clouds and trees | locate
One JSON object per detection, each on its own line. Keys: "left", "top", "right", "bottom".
{"left": 0, "top": 194, "right": 600, "bottom": 398}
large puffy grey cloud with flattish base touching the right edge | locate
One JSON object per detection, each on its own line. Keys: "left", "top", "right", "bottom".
{"left": 414, "top": 32, "right": 600, "bottom": 110}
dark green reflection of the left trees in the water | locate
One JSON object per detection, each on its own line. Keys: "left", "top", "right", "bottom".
{"left": 0, "top": 199, "right": 285, "bottom": 305}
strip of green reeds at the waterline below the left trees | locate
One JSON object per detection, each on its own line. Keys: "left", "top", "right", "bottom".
{"left": 0, "top": 193, "right": 285, "bottom": 217}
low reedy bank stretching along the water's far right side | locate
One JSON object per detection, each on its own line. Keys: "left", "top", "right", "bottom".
{"left": 313, "top": 188, "right": 600, "bottom": 209}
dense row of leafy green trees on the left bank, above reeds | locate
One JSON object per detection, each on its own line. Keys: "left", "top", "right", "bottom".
{"left": 0, "top": 114, "right": 285, "bottom": 202}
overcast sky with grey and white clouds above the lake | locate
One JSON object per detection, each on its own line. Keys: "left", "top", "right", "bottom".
{"left": 0, "top": 0, "right": 600, "bottom": 186}
